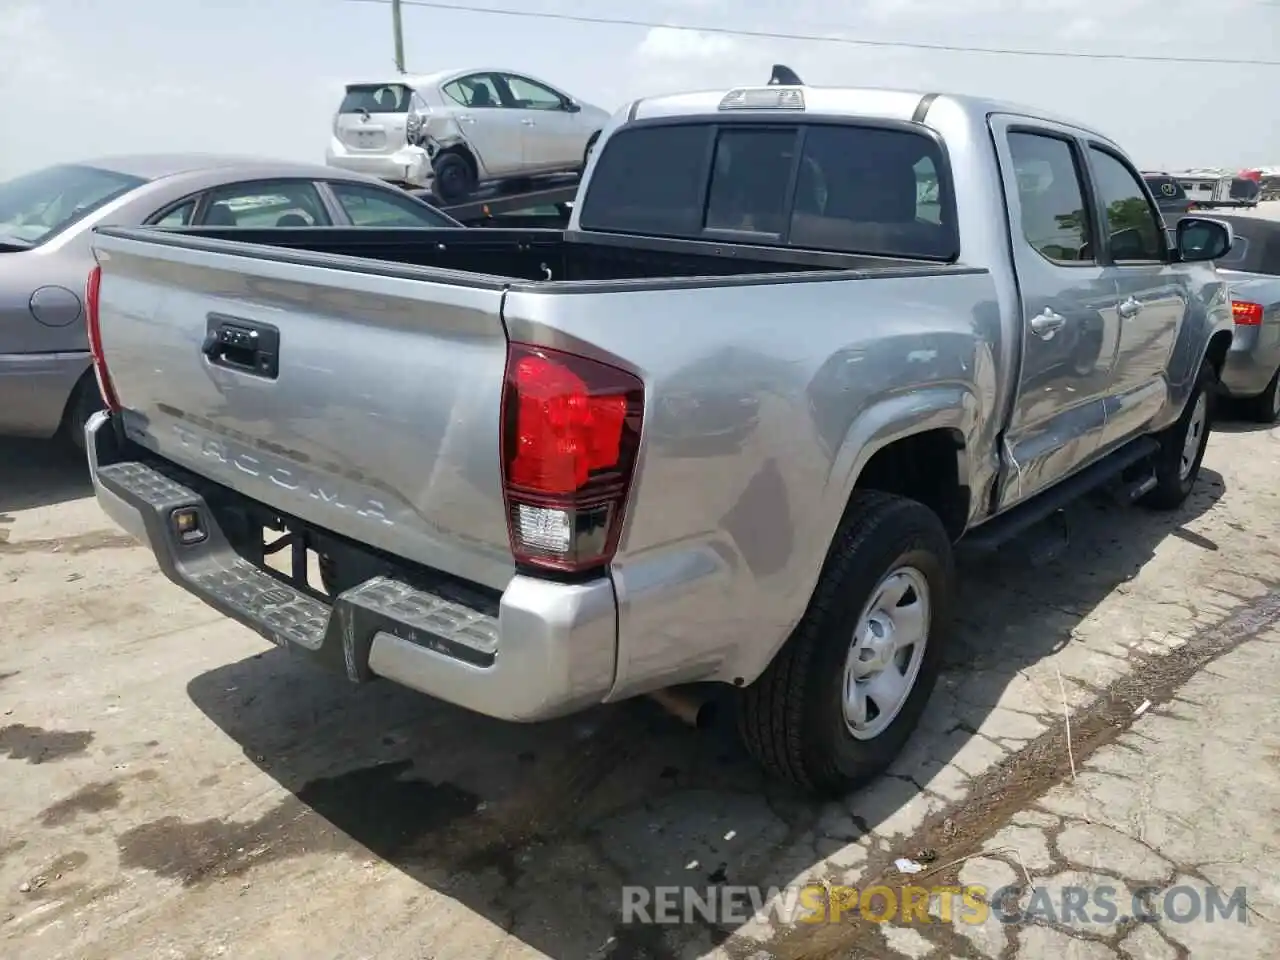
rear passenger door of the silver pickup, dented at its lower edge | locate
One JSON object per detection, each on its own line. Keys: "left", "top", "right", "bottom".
{"left": 992, "top": 116, "right": 1119, "bottom": 509}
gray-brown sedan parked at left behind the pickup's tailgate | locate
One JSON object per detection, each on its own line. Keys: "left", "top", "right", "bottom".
{"left": 0, "top": 154, "right": 458, "bottom": 444}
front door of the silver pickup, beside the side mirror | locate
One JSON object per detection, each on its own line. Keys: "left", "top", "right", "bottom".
{"left": 1089, "top": 143, "right": 1190, "bottom": 448}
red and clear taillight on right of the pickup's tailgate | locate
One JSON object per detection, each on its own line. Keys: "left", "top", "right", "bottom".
{"left": 502, "top": 343, "right": 644, "bottom": 572}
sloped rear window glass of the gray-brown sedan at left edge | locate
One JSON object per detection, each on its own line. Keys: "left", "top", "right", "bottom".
{"left": 0, "top": 164, "right": 146, "bottom": 247}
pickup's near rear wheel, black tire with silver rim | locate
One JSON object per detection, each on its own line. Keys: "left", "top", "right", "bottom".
{"left": 737, "top": 490, "right": 955, "bottom": 795}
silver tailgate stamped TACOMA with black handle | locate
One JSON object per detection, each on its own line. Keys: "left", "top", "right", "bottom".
{"left": 93, "top": 229, "right": 513, "bottom": 590}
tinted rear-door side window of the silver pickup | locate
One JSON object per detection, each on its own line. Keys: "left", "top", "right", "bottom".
{"left": 1009, "top": 132, "right": 1094, "bottom": 264}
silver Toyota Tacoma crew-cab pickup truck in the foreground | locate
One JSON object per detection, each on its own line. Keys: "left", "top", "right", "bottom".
{"left": 87, "top": 86, "right": 1233, "bottom": 792}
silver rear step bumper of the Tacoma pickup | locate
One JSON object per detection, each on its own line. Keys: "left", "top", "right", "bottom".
{"left": 84, "top": 412, "right": 617, "bottom": 722}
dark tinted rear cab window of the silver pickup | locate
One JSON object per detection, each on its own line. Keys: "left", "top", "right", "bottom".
{"left": 580, "top": 122, "right": 959, "bottom": 261}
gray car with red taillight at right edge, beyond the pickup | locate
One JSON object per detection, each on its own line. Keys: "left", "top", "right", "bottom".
{"left": 1192, "top": 216, "right": 1280, "bottom": 424}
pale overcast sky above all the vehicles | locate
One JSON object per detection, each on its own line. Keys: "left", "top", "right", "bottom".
{"left": 0, "top": 0, "right": 1280, "bottom": 178}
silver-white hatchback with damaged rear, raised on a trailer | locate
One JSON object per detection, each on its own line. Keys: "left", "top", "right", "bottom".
{"left": 325, "top": 69, "right": 609, "bottom": 202}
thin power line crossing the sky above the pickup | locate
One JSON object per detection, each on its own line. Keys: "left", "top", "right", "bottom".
{"left": 346, "top": 0, "right": 1280, "bottom": 67}
